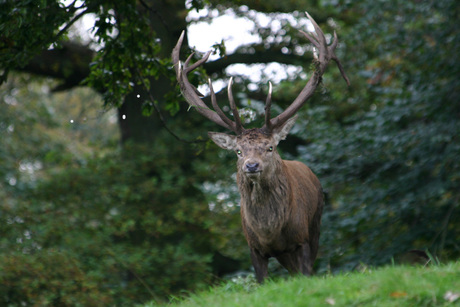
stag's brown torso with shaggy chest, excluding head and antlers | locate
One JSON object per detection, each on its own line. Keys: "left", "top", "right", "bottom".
{"left": 238, "top": 160, "right": 323, "bottom": 262}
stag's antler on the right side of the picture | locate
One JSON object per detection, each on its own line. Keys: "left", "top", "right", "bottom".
{"left": 263, "top": 12, "right": 350, "bottom": 132}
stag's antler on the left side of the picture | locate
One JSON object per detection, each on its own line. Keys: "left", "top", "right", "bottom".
{"left": 171, "top": 31, "right": 244, "bottom": 135}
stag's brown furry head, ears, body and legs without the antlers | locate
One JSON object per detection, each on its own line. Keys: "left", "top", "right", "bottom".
{"left": 210, "top": 121, "right": 323, "bottom": 282}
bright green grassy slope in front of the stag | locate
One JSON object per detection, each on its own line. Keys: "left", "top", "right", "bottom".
{"left": 144, "top": 262, "right": 460, "bottom": 307}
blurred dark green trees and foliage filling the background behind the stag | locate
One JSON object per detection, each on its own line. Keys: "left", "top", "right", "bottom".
{"left": 0, "top": 0, "right": 460, "bottom": 306}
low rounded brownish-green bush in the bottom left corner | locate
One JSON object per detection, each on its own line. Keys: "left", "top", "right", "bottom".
{"left": 0, "top": 250, "right": 113, "bottom": 306}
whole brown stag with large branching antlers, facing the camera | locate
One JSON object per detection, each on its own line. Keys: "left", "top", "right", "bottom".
{"left": 172, "top": 13, "right": 349, "bottom": 282}
